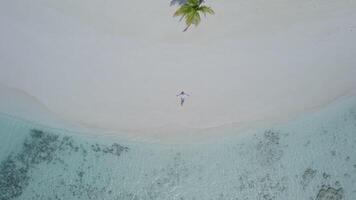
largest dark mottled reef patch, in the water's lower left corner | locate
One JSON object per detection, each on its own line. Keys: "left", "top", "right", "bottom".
{"left": 0, "top": 129, "right": 129, "bottom": 200}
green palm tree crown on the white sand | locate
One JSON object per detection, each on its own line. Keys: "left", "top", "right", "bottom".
{"left": 173, "top": 0, "right": 214, "bottom": 32}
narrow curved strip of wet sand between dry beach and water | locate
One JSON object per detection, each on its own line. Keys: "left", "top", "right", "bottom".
{"left": 0, "top": 85, "right": 356, "bottom": 144}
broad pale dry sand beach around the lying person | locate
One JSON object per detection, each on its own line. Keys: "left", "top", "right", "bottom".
{"left": 0, "top": 0, "right": 356, "bottom": 136}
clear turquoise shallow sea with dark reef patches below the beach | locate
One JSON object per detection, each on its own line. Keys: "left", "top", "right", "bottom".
{"left": 0, "top": 97, "right": 356, "bottom": 200}
